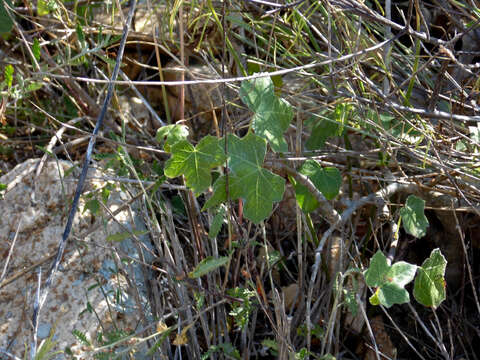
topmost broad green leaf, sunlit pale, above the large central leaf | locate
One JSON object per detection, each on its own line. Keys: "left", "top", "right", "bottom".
{"left": 240, "top": 77, "right": 293, "bottom": 152}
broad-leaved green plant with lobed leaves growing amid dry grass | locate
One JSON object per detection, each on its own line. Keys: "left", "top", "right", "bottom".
{"left": 157, "top": 77, "right": 446, "bottom": 310}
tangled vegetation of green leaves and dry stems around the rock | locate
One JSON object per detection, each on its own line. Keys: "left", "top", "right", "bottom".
{"left": 0, "top": 0, "right": 480, "bottom": 359}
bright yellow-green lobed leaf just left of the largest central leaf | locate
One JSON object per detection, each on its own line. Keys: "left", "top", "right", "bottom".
{"left": 165, "top": 136, "right": 226, "bottom": 194}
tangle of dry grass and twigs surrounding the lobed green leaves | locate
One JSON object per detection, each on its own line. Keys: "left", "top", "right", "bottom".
{"left": 0, "top": 0, "right": 480, "bottom": 359}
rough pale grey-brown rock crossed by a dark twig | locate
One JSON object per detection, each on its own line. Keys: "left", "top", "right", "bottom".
{"left": 0, "top": 159, "right": 152, "bottom": 358}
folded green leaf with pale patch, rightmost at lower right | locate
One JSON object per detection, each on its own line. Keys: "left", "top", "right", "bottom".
{"left": 413, "top": 249, "right": 447, "bottom": 309}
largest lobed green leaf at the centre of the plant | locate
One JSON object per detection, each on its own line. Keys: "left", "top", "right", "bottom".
{"left": 204, "top": 133, "right": 285, "bottom": 224}
